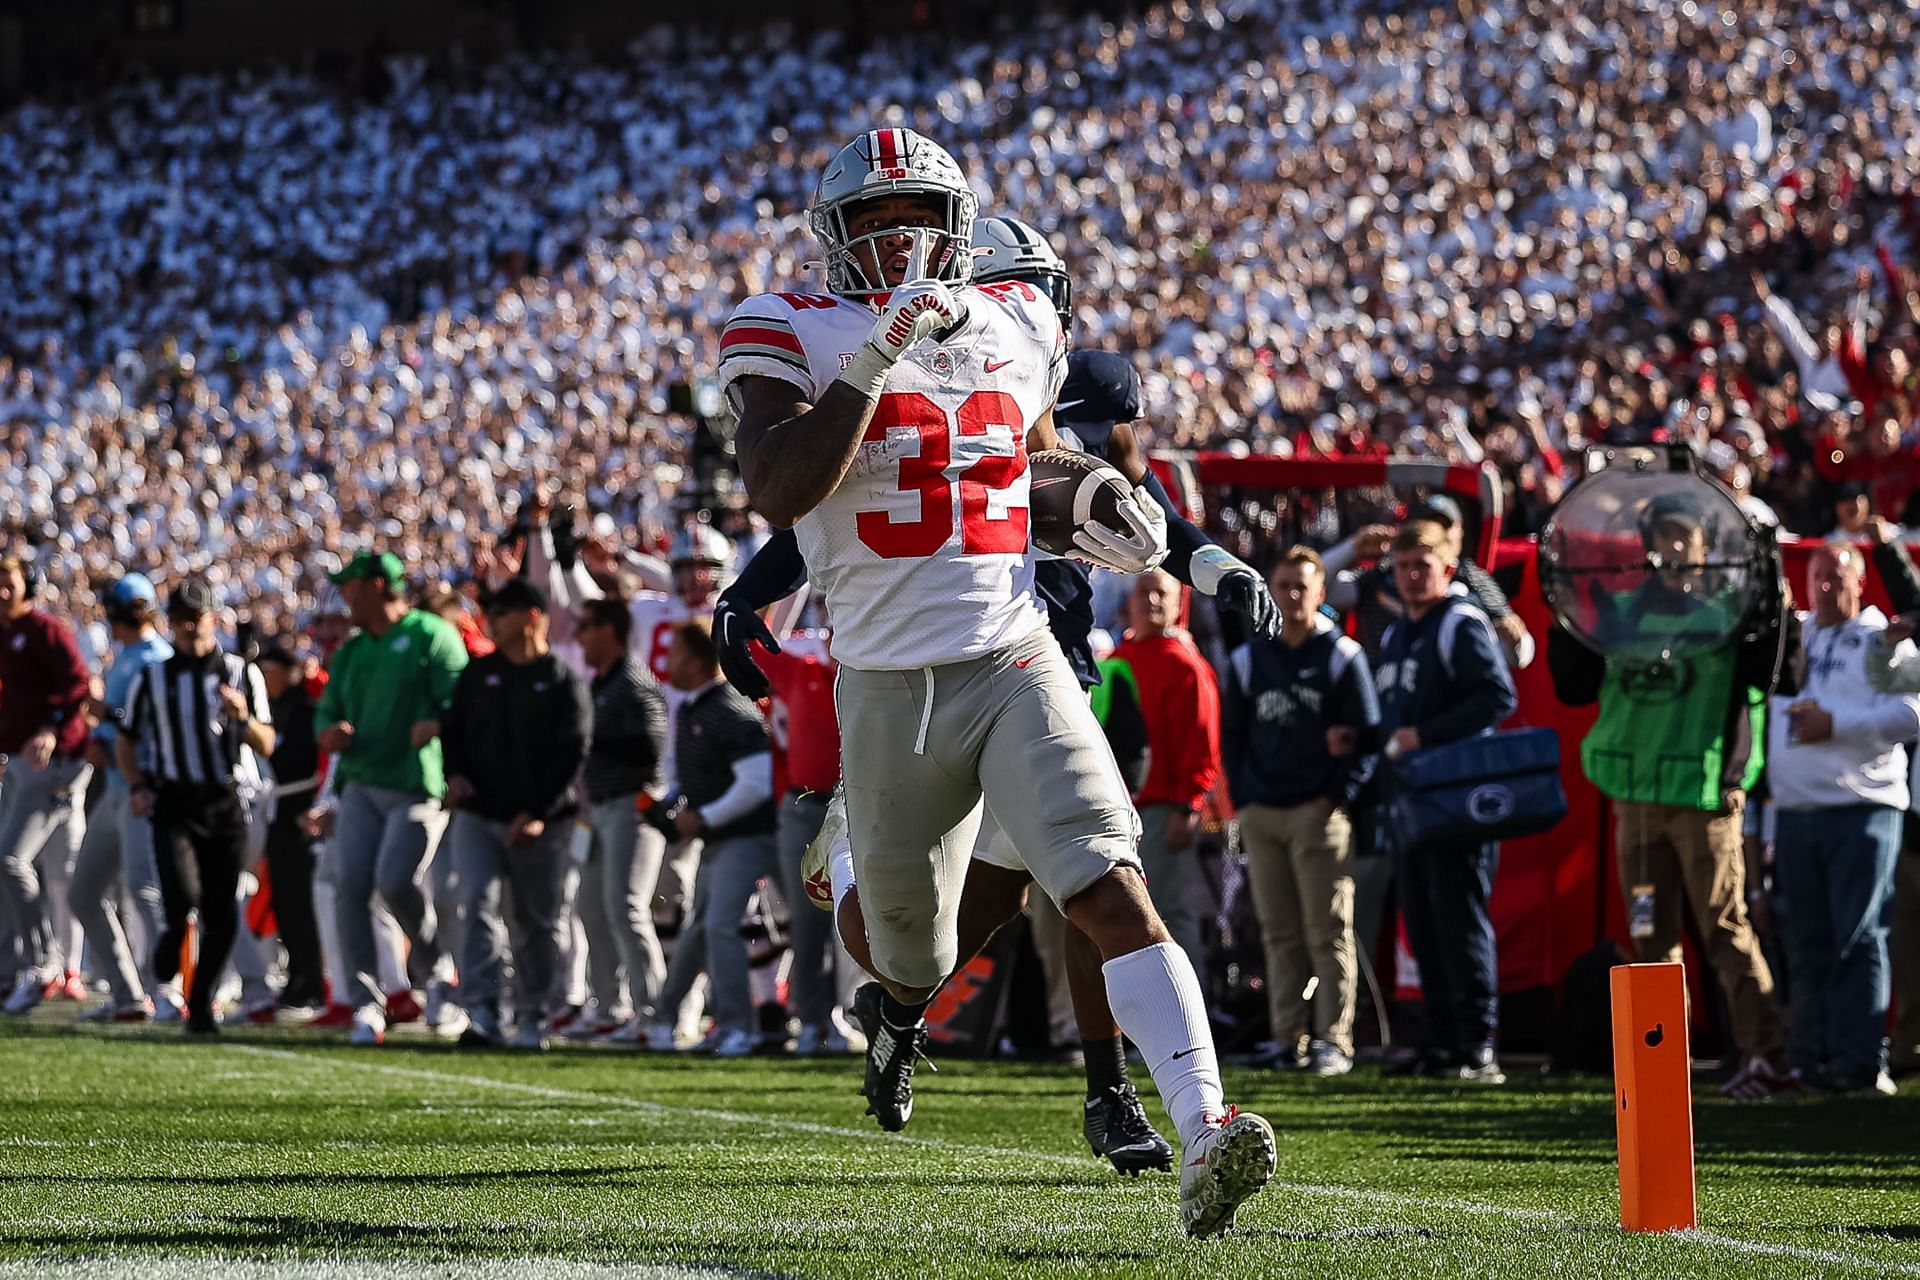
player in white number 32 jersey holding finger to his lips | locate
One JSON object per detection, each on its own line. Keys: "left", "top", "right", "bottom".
{"left": 720, "top": 129, "right": 1277, "bottom": 1236}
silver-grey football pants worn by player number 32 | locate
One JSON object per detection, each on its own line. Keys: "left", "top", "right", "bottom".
{"left": 833, "top": 631, "right": 1139, "bottom": 986}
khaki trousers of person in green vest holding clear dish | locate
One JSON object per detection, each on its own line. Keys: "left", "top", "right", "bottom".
{"left": 1613, "top": 793, "right": 1786, "bottom": 1067}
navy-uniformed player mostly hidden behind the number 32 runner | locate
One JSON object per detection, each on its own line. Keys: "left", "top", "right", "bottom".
{"left": 714, "top": 217, "right": 1277, "bottom": 1173}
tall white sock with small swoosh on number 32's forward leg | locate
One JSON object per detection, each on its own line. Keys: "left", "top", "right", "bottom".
{"left": 1100, "top": 942, "right": 1227, "bottom": 1148}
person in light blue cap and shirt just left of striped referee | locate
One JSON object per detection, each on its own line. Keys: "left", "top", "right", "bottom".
{"left": 69, "top": 574, "right": 174, "bottom": 1023}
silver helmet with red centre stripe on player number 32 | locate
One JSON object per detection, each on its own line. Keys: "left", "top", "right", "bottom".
{"left": 806, "top": 129, "right": 979, "bottom": 297}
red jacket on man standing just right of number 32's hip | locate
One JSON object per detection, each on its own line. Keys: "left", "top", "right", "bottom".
{"left": 1114, "top": 631, "right": 1219, "bottom": 808}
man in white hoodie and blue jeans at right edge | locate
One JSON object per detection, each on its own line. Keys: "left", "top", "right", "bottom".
{"left": 1766, "top": 543, "right": 1920, "bottom": 1094}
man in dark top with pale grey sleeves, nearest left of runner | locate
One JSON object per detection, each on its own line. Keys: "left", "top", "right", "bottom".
{"left": 647, "top": 620, "right": 778, "bottom": 1057}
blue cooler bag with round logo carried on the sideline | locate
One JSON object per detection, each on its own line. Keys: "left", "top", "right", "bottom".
{"left": 1386, "top": 729, "right": 1567, "bottom": 852}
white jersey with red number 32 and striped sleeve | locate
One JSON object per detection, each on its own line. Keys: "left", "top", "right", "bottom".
{"left": 720, "top": 282, "right": 1066, "bottom": 672}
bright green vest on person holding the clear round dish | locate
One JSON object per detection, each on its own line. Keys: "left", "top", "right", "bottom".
{"left": 1580, "top": 597, "right": 1766, "bottom": 810}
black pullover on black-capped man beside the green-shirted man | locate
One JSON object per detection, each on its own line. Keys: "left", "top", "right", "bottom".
{"left": 440, "top": 652, "right": 593, "bottom": 823}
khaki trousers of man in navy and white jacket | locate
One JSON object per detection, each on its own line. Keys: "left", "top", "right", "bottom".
{"left": 1240, "top": 800, "right": 1359, "bottom": 1054}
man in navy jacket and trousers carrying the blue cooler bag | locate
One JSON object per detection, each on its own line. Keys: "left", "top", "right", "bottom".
{"left": 1382, "top": 520, "right": 1519, "bottom": 1084}
